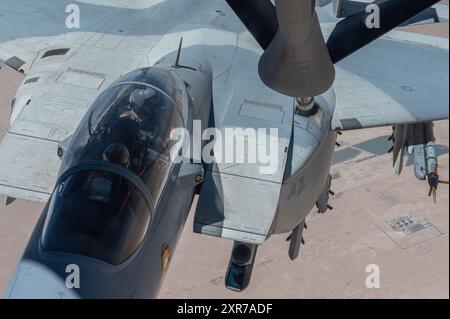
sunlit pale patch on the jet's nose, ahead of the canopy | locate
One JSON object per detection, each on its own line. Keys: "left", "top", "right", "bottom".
{"left": 4, "top": 260, "right": 79, "bottom": 299}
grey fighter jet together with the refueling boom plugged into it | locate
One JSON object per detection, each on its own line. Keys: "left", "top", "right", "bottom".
{"left": 0, "top": 0, "right": 448, "bottom": 298}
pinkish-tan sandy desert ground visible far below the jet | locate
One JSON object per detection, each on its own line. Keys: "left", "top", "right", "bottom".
{"left": 0, "top": 5, "right": 449, "bottom": 298}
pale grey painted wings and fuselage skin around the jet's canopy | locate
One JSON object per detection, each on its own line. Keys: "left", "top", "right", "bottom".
{"left": 0, "top": 0, "right": 448, "bottom": 298}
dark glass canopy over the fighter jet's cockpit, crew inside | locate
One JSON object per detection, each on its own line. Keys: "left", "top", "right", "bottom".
{"left": 42, "top": 67, "right": 188, "bottom": 264}
